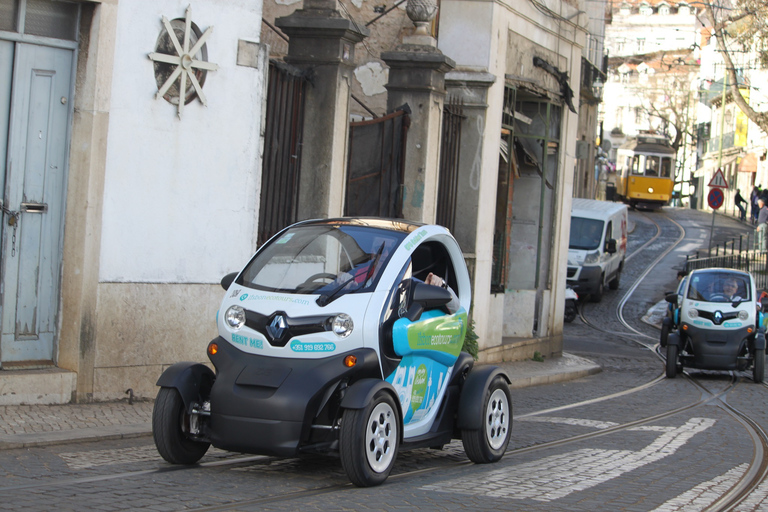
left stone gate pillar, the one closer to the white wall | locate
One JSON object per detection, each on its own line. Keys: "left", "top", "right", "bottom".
{"left": 275, "top": 0, "right": 369, "bottom": 219}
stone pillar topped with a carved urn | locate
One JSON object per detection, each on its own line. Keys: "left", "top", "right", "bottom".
{"left": 381, "top": 0, "right": 455, "bottom": 223}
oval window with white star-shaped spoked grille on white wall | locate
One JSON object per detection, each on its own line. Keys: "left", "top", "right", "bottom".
{"left": 149, "top": 7, "right": 219, "bottom": 118}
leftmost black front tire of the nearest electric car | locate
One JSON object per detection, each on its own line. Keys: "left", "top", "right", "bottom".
{"left": 152, "top": 388, "right": 210, "bottom": 464}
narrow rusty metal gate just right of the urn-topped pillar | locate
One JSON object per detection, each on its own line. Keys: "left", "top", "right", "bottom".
{"left": 437, "top": 98, "right": 466, "bottom": 231}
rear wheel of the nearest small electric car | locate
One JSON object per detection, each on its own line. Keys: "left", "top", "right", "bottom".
{"left": 461, "top": 375, "right": 512, "bottom": 464}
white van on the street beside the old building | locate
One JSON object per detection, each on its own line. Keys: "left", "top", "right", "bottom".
{"left": 567, "top": 199, "right": 627, "bottom": 302}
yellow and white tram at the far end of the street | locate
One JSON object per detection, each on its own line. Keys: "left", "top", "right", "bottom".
{"left": 616, "top": 135, "right": 675, "bottom": 208}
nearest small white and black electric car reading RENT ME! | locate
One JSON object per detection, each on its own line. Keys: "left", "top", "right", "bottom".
{"left": 152, "top": 218, "right": 512, "bottom": 486}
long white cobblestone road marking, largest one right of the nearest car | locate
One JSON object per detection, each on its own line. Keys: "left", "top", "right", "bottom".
{"left": 422, "top": 418, "right": 715, "bottom": 501}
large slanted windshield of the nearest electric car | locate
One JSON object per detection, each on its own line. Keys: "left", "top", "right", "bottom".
{"left": 238, "top": 224, "right": 407, "bottom": 296}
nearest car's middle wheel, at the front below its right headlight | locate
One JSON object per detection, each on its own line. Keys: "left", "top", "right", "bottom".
{"left": 339, "top": 391, "right": 401, "bottom": 487}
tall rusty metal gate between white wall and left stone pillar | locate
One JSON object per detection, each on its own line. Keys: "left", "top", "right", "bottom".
{"left": 257, "top": 61, "right": 308, "bottom": 245}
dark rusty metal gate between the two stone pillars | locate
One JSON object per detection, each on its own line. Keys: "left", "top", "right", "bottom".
{"left": 344, "top": 105, "right": 410, "bottom": 218}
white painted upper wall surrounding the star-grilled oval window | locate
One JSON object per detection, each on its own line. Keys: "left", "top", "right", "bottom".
{"left": 100, "top": 0, "right": 263, "bottom": 283}
